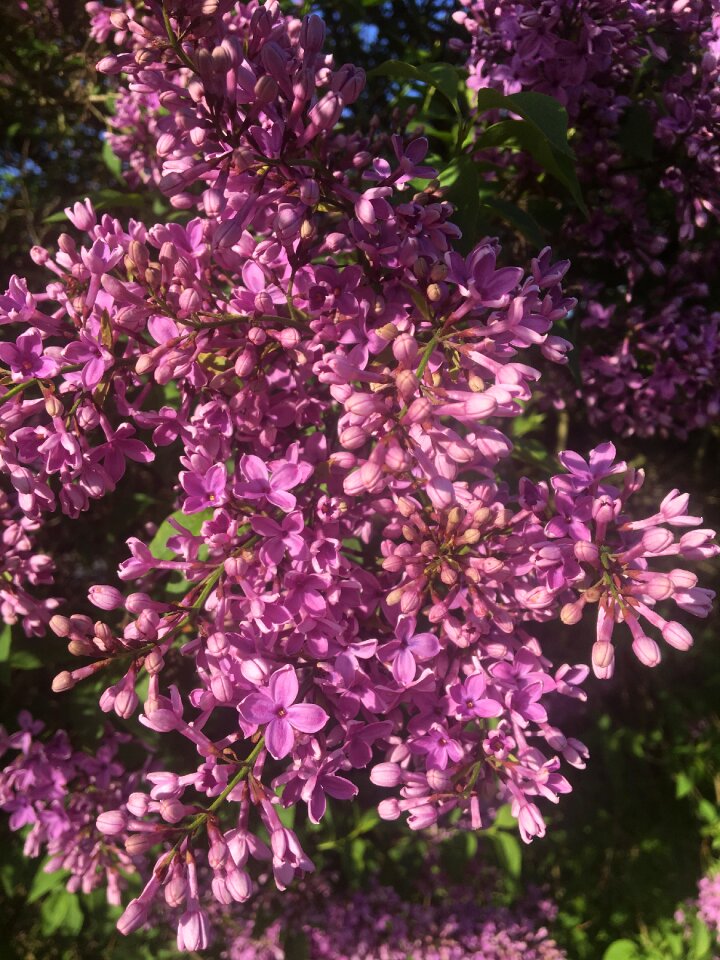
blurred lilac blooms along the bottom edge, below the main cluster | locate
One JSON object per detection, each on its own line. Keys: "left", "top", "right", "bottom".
{"left": 226, "top": 877, "right": 566, "bottom": 960}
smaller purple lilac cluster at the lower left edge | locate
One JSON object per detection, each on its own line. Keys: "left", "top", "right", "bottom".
{"left": 0, "top": 710, "right": 138, "bottom": 905}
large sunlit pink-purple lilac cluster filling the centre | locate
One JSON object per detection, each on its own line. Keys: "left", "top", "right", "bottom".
{"left": 0, "top": 0, "right": 718, "bottom": 950}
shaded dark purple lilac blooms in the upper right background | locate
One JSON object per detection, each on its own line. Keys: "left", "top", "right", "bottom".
{"left": 454, "top": 0, "right": 720, "bottom": 436}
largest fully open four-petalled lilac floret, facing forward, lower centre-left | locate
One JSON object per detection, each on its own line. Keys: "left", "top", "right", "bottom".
{"left": 239, "top": 664, "right": 328, "bottom": 760}
